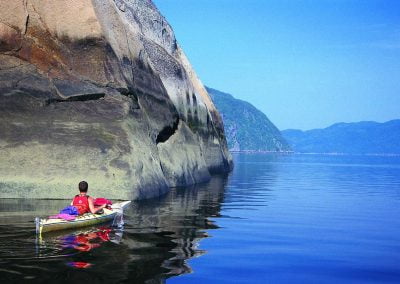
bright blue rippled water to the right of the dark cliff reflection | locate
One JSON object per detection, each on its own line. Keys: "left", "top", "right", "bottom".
{"left": 170, "top": 154, "right": 400, "bottom": 283}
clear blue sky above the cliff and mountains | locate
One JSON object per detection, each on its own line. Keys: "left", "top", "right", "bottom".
{"left": 153, "top": 0, "right": 400, "bottom": 129}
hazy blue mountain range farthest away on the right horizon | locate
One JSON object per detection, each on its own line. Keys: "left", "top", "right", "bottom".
{"left": 282, "top": 119, "right": 400, "bottom": 154}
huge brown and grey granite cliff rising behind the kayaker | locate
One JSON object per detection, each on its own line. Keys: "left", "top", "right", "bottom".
{"left": 0, "top": 0, "right": 232, "bottom": 199}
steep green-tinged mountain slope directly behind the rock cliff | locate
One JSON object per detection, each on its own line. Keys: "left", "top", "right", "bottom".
{"left": 207, "top": 87, "right": 291, "bottom": 152}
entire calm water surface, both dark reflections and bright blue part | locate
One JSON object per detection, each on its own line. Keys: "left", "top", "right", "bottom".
{"left": 0, "top": 154, "right": 400, "bottom": 283}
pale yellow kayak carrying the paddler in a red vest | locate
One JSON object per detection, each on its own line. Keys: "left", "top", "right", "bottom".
{"left": 35, "top": 201, "right": 131, "bottom": 235}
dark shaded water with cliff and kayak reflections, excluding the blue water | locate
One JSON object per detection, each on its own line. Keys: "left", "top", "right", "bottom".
{"left": 0, "top": 174, "right": 226, "bottom": 283}
